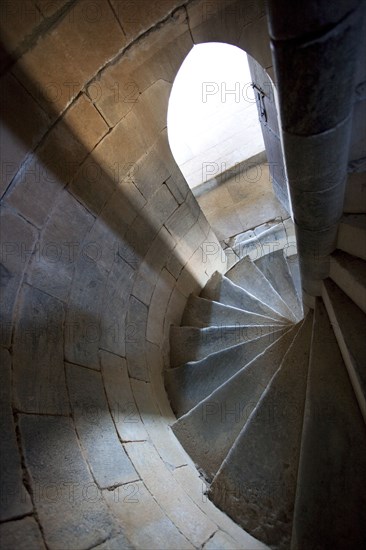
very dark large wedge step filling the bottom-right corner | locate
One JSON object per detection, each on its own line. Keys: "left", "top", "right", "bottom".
{"left": 291, "top": 299, "right": 366, "bottom": 550}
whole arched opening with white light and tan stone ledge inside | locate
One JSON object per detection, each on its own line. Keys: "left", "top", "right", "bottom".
{"left": 168, "top": 42, "right": 289, "bottom": 246}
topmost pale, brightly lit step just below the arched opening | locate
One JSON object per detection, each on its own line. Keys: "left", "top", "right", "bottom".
{"left": 231, "top": 219, "right": 296, "bottom": 261}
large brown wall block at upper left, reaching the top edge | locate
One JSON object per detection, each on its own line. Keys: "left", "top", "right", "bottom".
{"left": 14, "top": 0, "right": 126, "bottom": 118}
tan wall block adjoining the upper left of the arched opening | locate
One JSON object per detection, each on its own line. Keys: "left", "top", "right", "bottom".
{"left": 88, "top": 10, "right": 193, "bottom": 129}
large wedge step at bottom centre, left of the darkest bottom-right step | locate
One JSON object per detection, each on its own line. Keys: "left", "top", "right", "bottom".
{"left": 209, "top": 313, "right": 313, "bottom": 549}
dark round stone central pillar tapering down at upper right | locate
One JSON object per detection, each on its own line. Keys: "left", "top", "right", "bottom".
{"left": 268, "top": 0, "right": 365, "bottom": 296}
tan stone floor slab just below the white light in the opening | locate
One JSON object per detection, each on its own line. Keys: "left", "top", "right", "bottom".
{"left": 196, "top": 163, "right": 289, "bottom": 241}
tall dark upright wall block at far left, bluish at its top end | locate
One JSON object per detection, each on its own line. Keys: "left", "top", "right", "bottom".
{"left": 13, "top": 285, "right": 69, "bottom": 415}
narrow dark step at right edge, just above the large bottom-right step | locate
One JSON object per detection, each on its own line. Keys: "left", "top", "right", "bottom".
{"left": 322, "top": 279, "right": 366, "bottom": 422}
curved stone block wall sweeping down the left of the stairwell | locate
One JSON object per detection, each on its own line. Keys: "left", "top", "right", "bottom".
{"left": 0, "top": 0, "right": 271, "bottom": 550}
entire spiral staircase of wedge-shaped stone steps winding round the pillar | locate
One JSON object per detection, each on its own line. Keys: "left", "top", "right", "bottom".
{"left": 165, "top": 214, "right": 366, "bottom": 550}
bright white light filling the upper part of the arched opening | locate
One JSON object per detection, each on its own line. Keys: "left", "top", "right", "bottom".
{"left": 168, "top": 43, "right": 264, "bottom": 187}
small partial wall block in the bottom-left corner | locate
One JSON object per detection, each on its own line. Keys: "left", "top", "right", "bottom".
{"left": 0, "top": 517, "right": 46, "bottom": 550}
